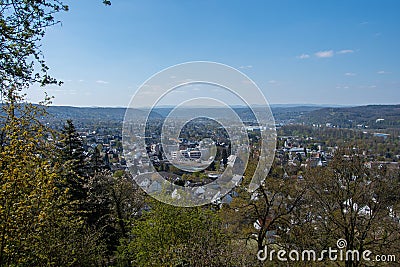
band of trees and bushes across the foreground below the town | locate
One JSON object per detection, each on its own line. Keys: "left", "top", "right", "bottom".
{"left": 0, "top": 105, "right": 400, "bottom": 266}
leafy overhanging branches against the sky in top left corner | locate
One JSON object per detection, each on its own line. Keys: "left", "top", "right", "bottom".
{"left": 0, "top": 0, "right": 68, "bottom": 94}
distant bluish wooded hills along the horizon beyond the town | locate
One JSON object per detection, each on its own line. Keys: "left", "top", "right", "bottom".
{"left": 32, "top": 105, "right": 400, "bottom": 129}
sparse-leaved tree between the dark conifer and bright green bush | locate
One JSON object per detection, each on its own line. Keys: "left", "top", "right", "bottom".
{"left": 85, "top": 171, "right": 144, "bottom": 257}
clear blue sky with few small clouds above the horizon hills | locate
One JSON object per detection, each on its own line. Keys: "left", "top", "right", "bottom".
{"left": 28, "top": 0, "right": 400, "bottom": 106}
